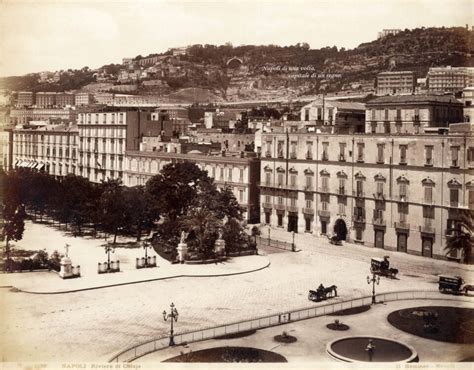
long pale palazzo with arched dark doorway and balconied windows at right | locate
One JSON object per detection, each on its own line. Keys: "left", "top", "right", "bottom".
{"left": 260, "top": 131, "right": 474, "bottom": 258}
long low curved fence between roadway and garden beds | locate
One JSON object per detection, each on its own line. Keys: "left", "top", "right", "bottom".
{"left": 109, "top": 290, "right": 472, "bottom": 362}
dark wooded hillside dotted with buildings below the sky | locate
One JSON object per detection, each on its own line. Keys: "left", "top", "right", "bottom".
{"left": 0, "top": 27, "right": 474, "bottom": 101}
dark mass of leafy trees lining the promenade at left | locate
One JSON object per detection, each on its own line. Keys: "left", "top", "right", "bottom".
{"left": 0, "top": 162, "right": 254, "bottom": 268}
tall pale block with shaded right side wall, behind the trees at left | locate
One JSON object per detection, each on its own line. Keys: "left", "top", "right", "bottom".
{"left": 77, "top": 107, "right": 158, "bottom": 182}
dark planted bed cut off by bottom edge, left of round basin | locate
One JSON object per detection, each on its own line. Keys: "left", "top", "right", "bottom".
{"left": 163, "top": 347, "right": 288, "bottom": 362}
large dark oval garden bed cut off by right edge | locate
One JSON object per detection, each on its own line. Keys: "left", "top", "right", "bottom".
{"left": 387, "top": 306, "right": 474, "bottom": 343}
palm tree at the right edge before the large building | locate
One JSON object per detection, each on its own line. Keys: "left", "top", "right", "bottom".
{"left": 445, "top": 211, "right": 474, "bottom": 263}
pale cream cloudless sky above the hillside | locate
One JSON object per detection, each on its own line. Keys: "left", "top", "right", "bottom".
{"left": 0, "top": 0, "right": 474, "bottom": 76}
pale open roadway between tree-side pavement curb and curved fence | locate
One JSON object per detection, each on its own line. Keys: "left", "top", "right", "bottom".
{"left": 0, "top": 221, "right": 469, "bottom": 362}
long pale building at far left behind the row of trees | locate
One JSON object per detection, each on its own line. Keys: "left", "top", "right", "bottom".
{"left": 12, "top": 122, "right": 79, "bottom": 176}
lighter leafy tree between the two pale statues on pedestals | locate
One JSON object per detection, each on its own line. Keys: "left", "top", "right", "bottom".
{"left": 181, "top": 207, "right": 222, "bottom": 256}
